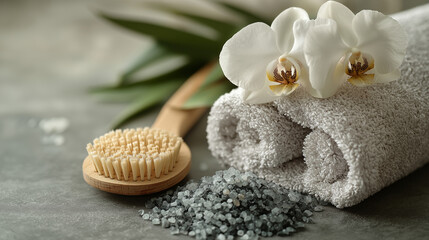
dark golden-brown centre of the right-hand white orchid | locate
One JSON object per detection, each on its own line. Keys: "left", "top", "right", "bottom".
{"left": 345, "top": 51, "right": 374, "bottom": 84}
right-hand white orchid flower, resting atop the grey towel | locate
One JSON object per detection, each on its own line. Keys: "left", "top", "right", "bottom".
{"left": 304, "top": 1, "right": 407, "bottom": 98}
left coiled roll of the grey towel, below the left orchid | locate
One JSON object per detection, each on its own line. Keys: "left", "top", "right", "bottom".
{"left": 207, "top": 89, "right": 310, "bottom": 170}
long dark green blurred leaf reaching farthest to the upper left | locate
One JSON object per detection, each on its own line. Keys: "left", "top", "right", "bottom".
{"left": 100, "top": 13, "right": 219, "bottom": 58}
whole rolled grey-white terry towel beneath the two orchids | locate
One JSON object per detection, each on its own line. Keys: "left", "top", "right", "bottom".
{"left": 207, "top": 4, "right": 429, "bottom": 208}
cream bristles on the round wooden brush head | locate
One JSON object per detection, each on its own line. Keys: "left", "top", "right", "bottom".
{"left": 86, "top": 127, "right": 183, "bottom": 181}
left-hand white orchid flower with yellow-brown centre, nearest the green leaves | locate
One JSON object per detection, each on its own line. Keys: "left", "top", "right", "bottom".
{"left": 219, "top": 8, "right": 323, "bottom": 104}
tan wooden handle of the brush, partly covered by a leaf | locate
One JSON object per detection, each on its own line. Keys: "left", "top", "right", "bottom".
{"left": 152, "top": 63, "right": 214, "bottom": 137}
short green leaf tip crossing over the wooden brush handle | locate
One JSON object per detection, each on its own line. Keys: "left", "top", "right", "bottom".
{"left": 182, "top": 80, "right": 234, "bottom": 109}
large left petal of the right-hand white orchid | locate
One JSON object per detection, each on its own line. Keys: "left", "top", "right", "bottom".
{"left": 304, "top": 21, "right": 348, "bottom": 98}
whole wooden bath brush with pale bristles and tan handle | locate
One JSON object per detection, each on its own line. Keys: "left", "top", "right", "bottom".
{"left": 82, "top": 64, "right": 213, "bottom": 195}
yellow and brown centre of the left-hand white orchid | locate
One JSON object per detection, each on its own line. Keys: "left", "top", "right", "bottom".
{"left": 267, "top": 56, "right": 300, "bottom": 95}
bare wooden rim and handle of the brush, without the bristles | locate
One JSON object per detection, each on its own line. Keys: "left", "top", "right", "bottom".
{"left": 82, "top": 64, "right": 214, "bottom": 195}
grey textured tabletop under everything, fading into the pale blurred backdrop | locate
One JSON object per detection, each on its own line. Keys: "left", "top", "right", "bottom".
{"left": 0, "top": 0, "right": 429, "bottom": 239}
